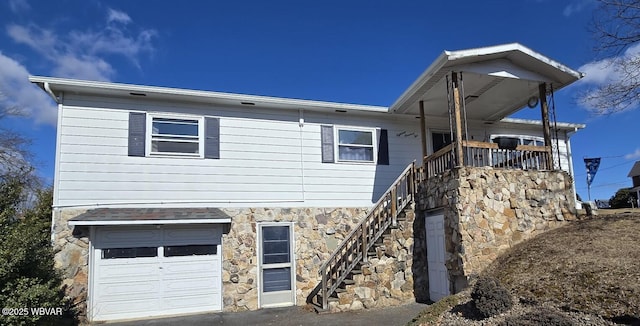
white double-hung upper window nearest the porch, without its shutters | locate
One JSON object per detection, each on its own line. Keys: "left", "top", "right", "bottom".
{"left": 336, "top": 127, "right": 376, "bottom": 163}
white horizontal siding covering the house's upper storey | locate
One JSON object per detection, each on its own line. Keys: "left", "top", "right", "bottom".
{"left": 54, "top": 94, "right": 566, "bottom": 207}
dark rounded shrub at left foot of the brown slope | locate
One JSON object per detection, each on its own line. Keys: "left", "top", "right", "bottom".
{"left": 471, "top": 277, "right": 513, "bottom": 318}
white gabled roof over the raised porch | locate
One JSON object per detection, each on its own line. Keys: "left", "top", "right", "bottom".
{"left": 390, "top": 43, "right": 584, "bottom": 121}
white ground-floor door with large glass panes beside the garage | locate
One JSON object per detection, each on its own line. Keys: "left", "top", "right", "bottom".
{"left": 258, "top": 223, "right": 295, "bottom": 307}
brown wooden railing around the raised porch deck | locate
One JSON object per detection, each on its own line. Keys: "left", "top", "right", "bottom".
{"left": 424, "top": 140, "right": 552, "bottom": 178}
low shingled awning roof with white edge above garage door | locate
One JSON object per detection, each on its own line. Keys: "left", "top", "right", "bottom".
{"left": 69, "top": 208, "right": 231, "bottom": 226}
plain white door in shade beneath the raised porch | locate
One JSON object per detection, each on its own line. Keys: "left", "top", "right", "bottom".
{"left": 425, "top": 214, "right": 449, "bottom": 302}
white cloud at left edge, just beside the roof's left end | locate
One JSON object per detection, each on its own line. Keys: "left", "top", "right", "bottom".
{"left": 0, "top": 52, "right": 58, "bottom": 126}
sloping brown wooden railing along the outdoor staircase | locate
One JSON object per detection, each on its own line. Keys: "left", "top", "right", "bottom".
{"left": 316, "top": 162, "right": 421, "bottom": 310}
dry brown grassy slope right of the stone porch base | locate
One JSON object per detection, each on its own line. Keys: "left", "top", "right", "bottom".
{"left": 407, "top": 209, "right": 640, "bottom": 326}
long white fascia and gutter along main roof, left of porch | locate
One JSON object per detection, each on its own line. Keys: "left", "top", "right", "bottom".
{"left": 29, "top": 76, "right": 389, "bottom": 113}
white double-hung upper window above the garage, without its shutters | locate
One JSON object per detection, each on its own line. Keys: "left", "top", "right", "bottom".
{"left": 148, "top": 115, "right": 204, "bottom": 157}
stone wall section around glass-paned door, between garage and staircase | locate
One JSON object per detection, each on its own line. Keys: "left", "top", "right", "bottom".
{"left": 222, "top": 208, "right": 369, "bottom": 311}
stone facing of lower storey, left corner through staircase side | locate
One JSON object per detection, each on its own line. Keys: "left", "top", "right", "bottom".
{"left": 53, "top": 208, "right": 420, "bottom": 314}
